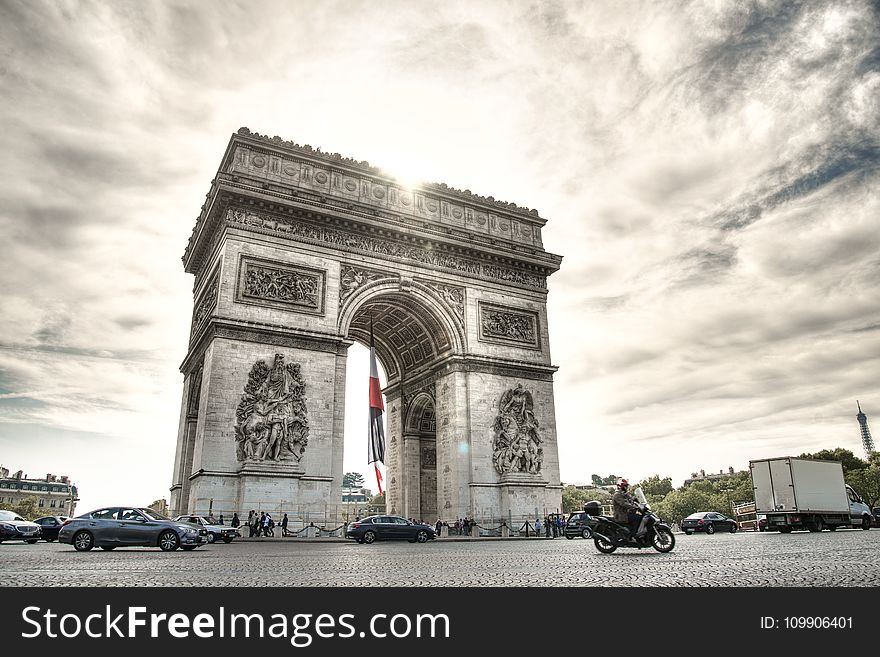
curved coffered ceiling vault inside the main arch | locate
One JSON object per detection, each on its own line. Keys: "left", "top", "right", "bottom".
{"left": 348, "top": 292, "right": 452, "bottom": 383}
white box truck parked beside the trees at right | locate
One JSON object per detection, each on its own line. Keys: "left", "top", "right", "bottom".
{"left": 749, "top": 456, "right": 871, "bottom": 534}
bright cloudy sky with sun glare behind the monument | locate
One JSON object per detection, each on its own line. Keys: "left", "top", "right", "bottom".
{"left": 0, "top": 0, "right": 880, "bottom": 512}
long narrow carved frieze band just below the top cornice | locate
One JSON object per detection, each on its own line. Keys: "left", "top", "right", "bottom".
{"left": 226, "top": 208, "right": 547, "bottom": 290}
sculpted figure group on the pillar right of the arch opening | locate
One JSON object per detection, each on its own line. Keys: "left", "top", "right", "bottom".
{"left": 492, "top": 383, "right": 544, "bottom": 475}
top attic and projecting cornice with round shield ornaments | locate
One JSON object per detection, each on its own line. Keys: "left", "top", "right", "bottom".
{"left": 183, "top": 135, "right": 562, "bottom": 273}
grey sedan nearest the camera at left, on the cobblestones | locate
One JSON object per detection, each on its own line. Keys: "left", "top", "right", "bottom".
{"left": 58, "top": 506, "right": 208, "bottom": 552}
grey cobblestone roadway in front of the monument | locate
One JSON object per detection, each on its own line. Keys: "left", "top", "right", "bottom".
{"left": 0, "top": 530, "right": 880, "bottom": 586}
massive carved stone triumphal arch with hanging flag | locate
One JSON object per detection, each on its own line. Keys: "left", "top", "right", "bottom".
{"left": 171, "top": 128, "right": 561, "bottom": 521}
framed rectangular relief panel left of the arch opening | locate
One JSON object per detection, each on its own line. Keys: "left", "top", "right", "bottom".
{"left": 235, "top": 256, "right": 325, "bottom": 314}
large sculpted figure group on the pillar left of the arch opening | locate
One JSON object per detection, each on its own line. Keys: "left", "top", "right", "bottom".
{"left": 235, "top": 354, "right": 309, "bottom": 462}
